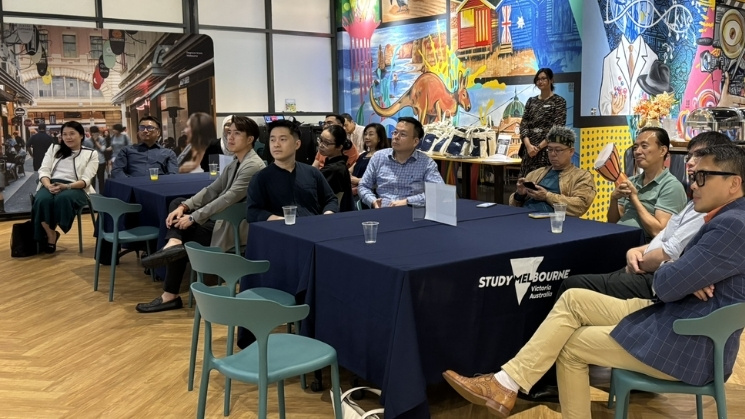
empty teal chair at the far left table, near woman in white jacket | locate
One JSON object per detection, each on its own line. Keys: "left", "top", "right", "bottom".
{"left": 88, "top": 195, "right": 159, "bottom": 302}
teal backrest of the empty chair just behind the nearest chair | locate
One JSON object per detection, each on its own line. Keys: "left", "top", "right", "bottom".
{"left": 184, "top": 242, "right": 269, "bottom": 295}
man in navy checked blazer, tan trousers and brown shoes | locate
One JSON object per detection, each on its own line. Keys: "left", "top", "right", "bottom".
{"left": 443, "top": 145, "right": 745, "bottom": 418}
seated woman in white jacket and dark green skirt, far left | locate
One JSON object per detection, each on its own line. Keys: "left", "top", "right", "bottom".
{"left": 31, "top": 121, "right": 98, "bottom": 253}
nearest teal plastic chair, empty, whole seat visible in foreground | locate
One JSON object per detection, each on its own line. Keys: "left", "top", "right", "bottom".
{"left": 191, "top": 282, "right": 342, "bottom": 419}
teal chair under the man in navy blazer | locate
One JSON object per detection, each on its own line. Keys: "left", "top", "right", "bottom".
{"left": 608, "top": 303, "right": 745, "bottom": 419}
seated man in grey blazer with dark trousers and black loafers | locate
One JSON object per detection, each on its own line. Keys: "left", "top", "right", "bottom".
{"left": 136, "top": 116, "right": 265, "bottom": 313}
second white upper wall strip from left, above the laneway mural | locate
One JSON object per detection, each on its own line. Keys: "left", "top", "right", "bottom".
{"left": 101, "top": 0, "right": 184, "bottom": 23}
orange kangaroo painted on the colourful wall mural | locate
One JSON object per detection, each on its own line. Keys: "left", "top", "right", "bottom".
{"left": 370, "top": 73, "right": 471, "bottom": 124}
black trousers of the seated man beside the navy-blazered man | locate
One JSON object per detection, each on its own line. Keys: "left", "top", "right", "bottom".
{"left": 556, "top": 269, "right": 654, "bottom": 300}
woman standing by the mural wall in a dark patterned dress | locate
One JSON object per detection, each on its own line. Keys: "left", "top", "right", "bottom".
{"left": 519, "top": 68, "right": 567, "bottom": 177}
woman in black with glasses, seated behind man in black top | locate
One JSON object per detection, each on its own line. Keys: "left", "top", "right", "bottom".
{"left": 318, "top": 125, "right": 354, "bottom": 211}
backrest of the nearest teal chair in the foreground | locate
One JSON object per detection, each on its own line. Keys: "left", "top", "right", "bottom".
{"left": 191, "top": 282, "right": 310, "bottom": 344}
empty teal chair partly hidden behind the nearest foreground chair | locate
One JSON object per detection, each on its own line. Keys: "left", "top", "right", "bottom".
{"left": 184, "top": 242, "right": 305, "bottom": 398}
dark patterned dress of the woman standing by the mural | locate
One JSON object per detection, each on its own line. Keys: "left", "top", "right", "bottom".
{"left": 519, "top": 94, "right": 567, "bottom": 177}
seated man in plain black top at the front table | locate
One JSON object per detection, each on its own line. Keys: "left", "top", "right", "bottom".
{"left": 246, "top": 120, "right": 339, "bottom": 223}
